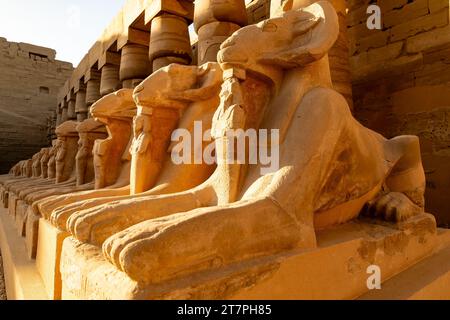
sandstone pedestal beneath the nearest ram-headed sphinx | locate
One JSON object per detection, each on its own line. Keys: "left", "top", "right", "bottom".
{"left": 61, "top": 214, "right": 450, "bottom": 299}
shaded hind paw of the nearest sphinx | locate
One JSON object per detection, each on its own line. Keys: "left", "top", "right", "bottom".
{"left": 364, "top": 192, "right": 423, "bottom": 222}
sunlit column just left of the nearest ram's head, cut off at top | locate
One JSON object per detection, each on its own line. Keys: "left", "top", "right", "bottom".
{"left": 194, "top": 0, "right": 248, "bottom": 65}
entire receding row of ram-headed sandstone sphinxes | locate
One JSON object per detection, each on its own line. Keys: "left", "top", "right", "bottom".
{"left": 0, "top": 1, "right": 425, "bottom": 298}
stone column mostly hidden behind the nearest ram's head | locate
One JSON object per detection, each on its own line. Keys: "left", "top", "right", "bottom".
{"left": 270, "top": 0, "right": 353, "bottom": 109}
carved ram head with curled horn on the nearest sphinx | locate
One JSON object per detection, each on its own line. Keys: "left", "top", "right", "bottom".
{"left": 218, "top": 1, "right": 339, "bottom": 82}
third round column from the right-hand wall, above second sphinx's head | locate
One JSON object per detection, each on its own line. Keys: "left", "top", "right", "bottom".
{"left": 149, "top": 13, "right": 192, "bottom": 71}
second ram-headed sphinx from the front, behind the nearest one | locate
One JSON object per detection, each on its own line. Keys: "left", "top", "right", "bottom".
{"left": 37, "top": 63, "right": 222, "bottom": 230}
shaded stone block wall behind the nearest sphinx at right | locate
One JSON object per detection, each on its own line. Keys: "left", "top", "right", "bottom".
{"left": 347, "top": 0, "right": 450, "bottom": 226}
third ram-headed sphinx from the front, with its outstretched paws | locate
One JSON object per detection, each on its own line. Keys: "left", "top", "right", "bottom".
{"left": 32, "top": 89, "right": 136, "bottom": 228}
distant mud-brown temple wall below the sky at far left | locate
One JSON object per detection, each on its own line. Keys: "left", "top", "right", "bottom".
{"left": 0, "top": 38, "right": 73, "bottom": 174}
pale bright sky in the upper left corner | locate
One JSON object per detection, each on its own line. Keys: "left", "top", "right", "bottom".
{"left": 0, "top": 0, "right": 125, "bottom": 66}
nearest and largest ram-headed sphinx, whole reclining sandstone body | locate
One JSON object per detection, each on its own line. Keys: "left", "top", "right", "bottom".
{"left": 58, "top": 1, "right": 425, "bottom": 284}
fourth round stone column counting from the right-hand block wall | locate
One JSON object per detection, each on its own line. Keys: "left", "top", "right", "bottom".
{"left": 119, "top": 43, "right": 152, "bottom": 89}
